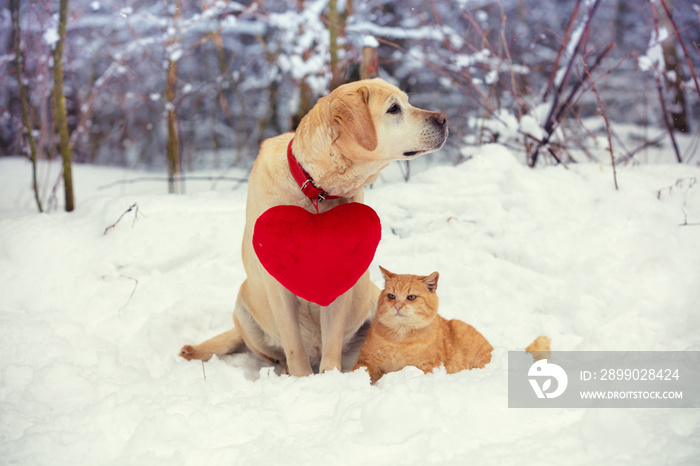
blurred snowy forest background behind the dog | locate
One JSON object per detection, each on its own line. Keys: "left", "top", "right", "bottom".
{"left": 0, "top": 0, "right": 700, "bottom": 210}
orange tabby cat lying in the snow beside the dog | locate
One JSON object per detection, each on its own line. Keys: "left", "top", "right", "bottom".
{"left": 353, "top": 267, "right": 493, "bottom": 383}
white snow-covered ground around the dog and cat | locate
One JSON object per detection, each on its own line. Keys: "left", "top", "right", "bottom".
{"left": 0, "top": 146, "right": 700, "bottom": 466}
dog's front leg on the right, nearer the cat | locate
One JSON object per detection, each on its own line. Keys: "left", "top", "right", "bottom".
{"left": 319, "top": 290, "right": 352, "bottom": 372}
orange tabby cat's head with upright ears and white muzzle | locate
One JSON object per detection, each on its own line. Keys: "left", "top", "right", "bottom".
{"left": 377, "top": 267, "right": 439, "bottom": 330}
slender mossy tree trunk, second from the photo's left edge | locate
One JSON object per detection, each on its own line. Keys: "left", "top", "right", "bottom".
{"left": 53, "top": 0, "right": 75, "bottom": 212}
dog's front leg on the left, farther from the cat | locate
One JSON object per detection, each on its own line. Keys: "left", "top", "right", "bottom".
{"left": 270, "top": 290, "right": 313, "bottom": 377}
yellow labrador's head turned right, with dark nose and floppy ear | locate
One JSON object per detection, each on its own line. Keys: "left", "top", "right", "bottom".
{"left": 324, "top": 79, "right": 448, "bottom": 162}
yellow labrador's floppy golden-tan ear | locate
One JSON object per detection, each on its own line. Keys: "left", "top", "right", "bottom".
{"left": 331, "top": 87, "right": 377, "bottom": 151}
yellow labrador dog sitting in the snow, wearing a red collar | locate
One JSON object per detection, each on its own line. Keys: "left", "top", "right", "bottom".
{"left": 180, "top": 79, "right": 447, "bottom": 376}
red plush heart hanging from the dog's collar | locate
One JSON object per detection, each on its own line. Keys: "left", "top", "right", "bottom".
{"left": 253, "top": 202, "right": 382, "bottom": 306}
